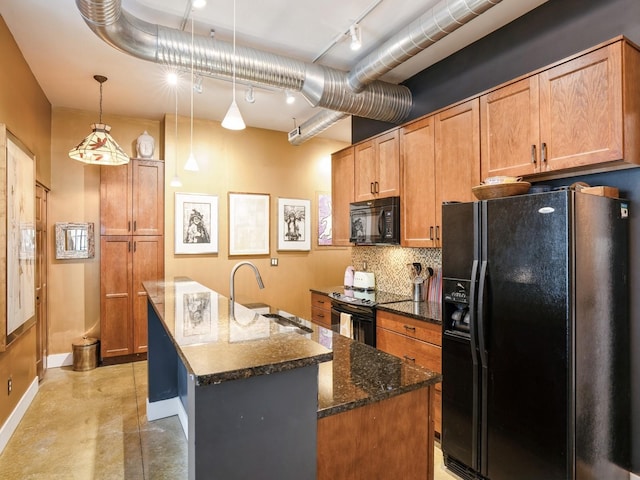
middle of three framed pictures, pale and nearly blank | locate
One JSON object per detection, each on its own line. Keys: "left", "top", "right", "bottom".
{"left": 229, "top": 192, "right": 271, "bottom": 255}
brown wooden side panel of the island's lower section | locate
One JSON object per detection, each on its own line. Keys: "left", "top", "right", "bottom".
{"left": 317, "top": 386, "right": 434, "bottom": 480}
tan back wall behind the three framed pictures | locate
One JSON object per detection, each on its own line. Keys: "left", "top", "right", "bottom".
{"left": 165, "top": 115, "right": 350, "bottom": 318}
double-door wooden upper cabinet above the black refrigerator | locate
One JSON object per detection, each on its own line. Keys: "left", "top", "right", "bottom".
{"left": 480, "top": 40, "right": 640, "bottom": 179}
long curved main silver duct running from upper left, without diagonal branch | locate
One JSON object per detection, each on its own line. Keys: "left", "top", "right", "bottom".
{"left": 76, "top": 0, "right": 411, "bottom": 123}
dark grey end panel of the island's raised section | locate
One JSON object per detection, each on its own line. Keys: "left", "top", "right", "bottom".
{"left": 188, "top": 365, "right": 318, "bottom": 480}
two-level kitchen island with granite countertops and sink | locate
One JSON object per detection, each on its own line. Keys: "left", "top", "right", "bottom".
{"left": 145, "top": 278, "right": 440, "bottom": 479}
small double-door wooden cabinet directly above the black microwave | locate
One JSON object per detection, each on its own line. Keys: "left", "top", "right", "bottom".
{"left": 354, "top": 129, "right": 400, "bottom": 202}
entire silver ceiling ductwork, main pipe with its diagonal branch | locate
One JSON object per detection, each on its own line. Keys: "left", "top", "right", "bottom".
{"left": 76, "top": 0, "right": 501, "bottom": 145}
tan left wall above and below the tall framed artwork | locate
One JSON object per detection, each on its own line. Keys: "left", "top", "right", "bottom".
{"left": 0, "top": 17, "right": 51, "bottom": 425}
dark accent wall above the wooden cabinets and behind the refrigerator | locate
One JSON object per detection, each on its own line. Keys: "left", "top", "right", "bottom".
{"left": 352, "top": 0, "right": 640, "bottom": 474}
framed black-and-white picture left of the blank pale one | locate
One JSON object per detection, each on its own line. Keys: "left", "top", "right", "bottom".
{"left": 174, "top": 193, "right": 218, "bottom": 254}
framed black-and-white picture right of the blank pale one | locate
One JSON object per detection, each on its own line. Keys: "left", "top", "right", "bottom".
{"left": 278, "top": 198, "right": 311, "bottom": 251}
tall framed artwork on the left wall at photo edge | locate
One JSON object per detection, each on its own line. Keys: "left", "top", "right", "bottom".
{"left": 0, "top": 124, "right": 36, "bottom": 351}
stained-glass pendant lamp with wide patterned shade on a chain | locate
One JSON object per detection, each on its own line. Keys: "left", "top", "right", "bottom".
{"left": 69, "top": 75, "right": 129, "bottom": 165}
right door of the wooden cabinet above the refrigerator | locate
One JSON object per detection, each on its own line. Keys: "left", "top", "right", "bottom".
{"left": 539, "top": 42, "right": 623, "bottom": 170}
